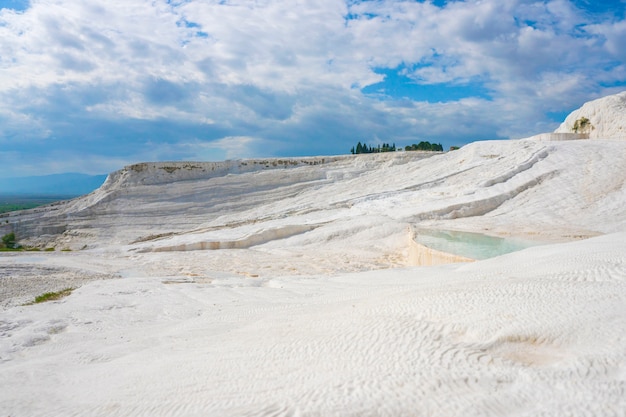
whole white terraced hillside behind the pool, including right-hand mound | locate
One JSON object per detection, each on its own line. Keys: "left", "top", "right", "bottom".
{"left": 0, "top": 88, "right": 626, "bottom": 251}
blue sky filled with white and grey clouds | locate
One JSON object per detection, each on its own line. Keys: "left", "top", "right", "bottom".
{"left": 0, "top": 0, "right": 626, "bottom": 177}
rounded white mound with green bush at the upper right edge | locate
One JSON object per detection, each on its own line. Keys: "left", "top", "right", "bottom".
{"left": 554, "top": 91, "right": 626, "bottom": 140}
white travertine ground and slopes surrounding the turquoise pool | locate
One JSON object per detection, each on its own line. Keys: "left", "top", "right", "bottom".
{"left": 0, "top": 93, "right": 626, "bottom": 417}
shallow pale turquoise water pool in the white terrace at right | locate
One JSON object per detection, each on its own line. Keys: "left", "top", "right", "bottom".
{"left": 415, "top": 229, "right": 541, "bottom": 260}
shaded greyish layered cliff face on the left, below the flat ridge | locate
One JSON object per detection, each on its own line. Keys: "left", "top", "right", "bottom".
{"left": 0, "top": 152, "right": 424, "bottom": 249}
